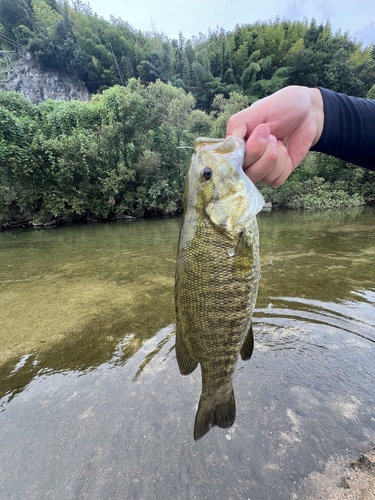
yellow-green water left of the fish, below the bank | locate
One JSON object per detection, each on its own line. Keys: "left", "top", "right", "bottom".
{"left": 0, "top": 219, "right": 179, "bottom": 402}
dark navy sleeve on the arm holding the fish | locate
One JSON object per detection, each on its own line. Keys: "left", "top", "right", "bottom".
{"left": 311, "top": 87, "right": 375, "bottom": 170}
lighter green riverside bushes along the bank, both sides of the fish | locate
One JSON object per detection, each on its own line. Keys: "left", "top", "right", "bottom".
{"left": 0, "top": 79, "right": 375, "bottom": 221}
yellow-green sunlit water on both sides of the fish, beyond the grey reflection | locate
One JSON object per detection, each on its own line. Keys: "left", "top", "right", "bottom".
{"left": 0, "top": 208, "right": 375, "bottom": 396}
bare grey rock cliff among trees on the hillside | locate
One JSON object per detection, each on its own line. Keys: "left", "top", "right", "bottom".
{"left": 0, "top": 54, "right": 90, "bottom": 104}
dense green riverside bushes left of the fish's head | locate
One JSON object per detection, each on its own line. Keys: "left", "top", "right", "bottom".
{"left": 0, "top": 79, "right": 206, "bottom": 219}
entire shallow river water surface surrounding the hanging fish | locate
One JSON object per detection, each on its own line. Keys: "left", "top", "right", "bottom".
{"left": 0, "top": 208, "right": 375, "bottom": 500}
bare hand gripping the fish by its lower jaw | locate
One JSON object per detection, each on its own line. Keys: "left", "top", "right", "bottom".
{"left": 227, "top": 86, "right": 324, "bottom": 187}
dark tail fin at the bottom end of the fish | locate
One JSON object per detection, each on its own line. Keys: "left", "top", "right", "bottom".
{"left": 194, "top": 388, "right": 236, "bottom": 441}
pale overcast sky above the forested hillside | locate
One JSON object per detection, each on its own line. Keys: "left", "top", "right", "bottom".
{"left": 88, "top": 0, "right": 375, "bottom": 45}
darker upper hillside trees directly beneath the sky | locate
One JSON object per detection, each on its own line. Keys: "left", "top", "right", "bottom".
{"left": 0, "top": 0, "right": 375, "bottom": 101}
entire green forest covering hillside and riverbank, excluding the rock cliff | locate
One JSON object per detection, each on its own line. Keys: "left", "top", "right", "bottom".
{"left": 0, "top": 0, "right": 375, "bottom": 222}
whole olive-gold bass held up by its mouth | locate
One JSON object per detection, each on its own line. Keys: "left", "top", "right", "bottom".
{"left": 175, "top": 136, "right": 264, "bottom": 440}
